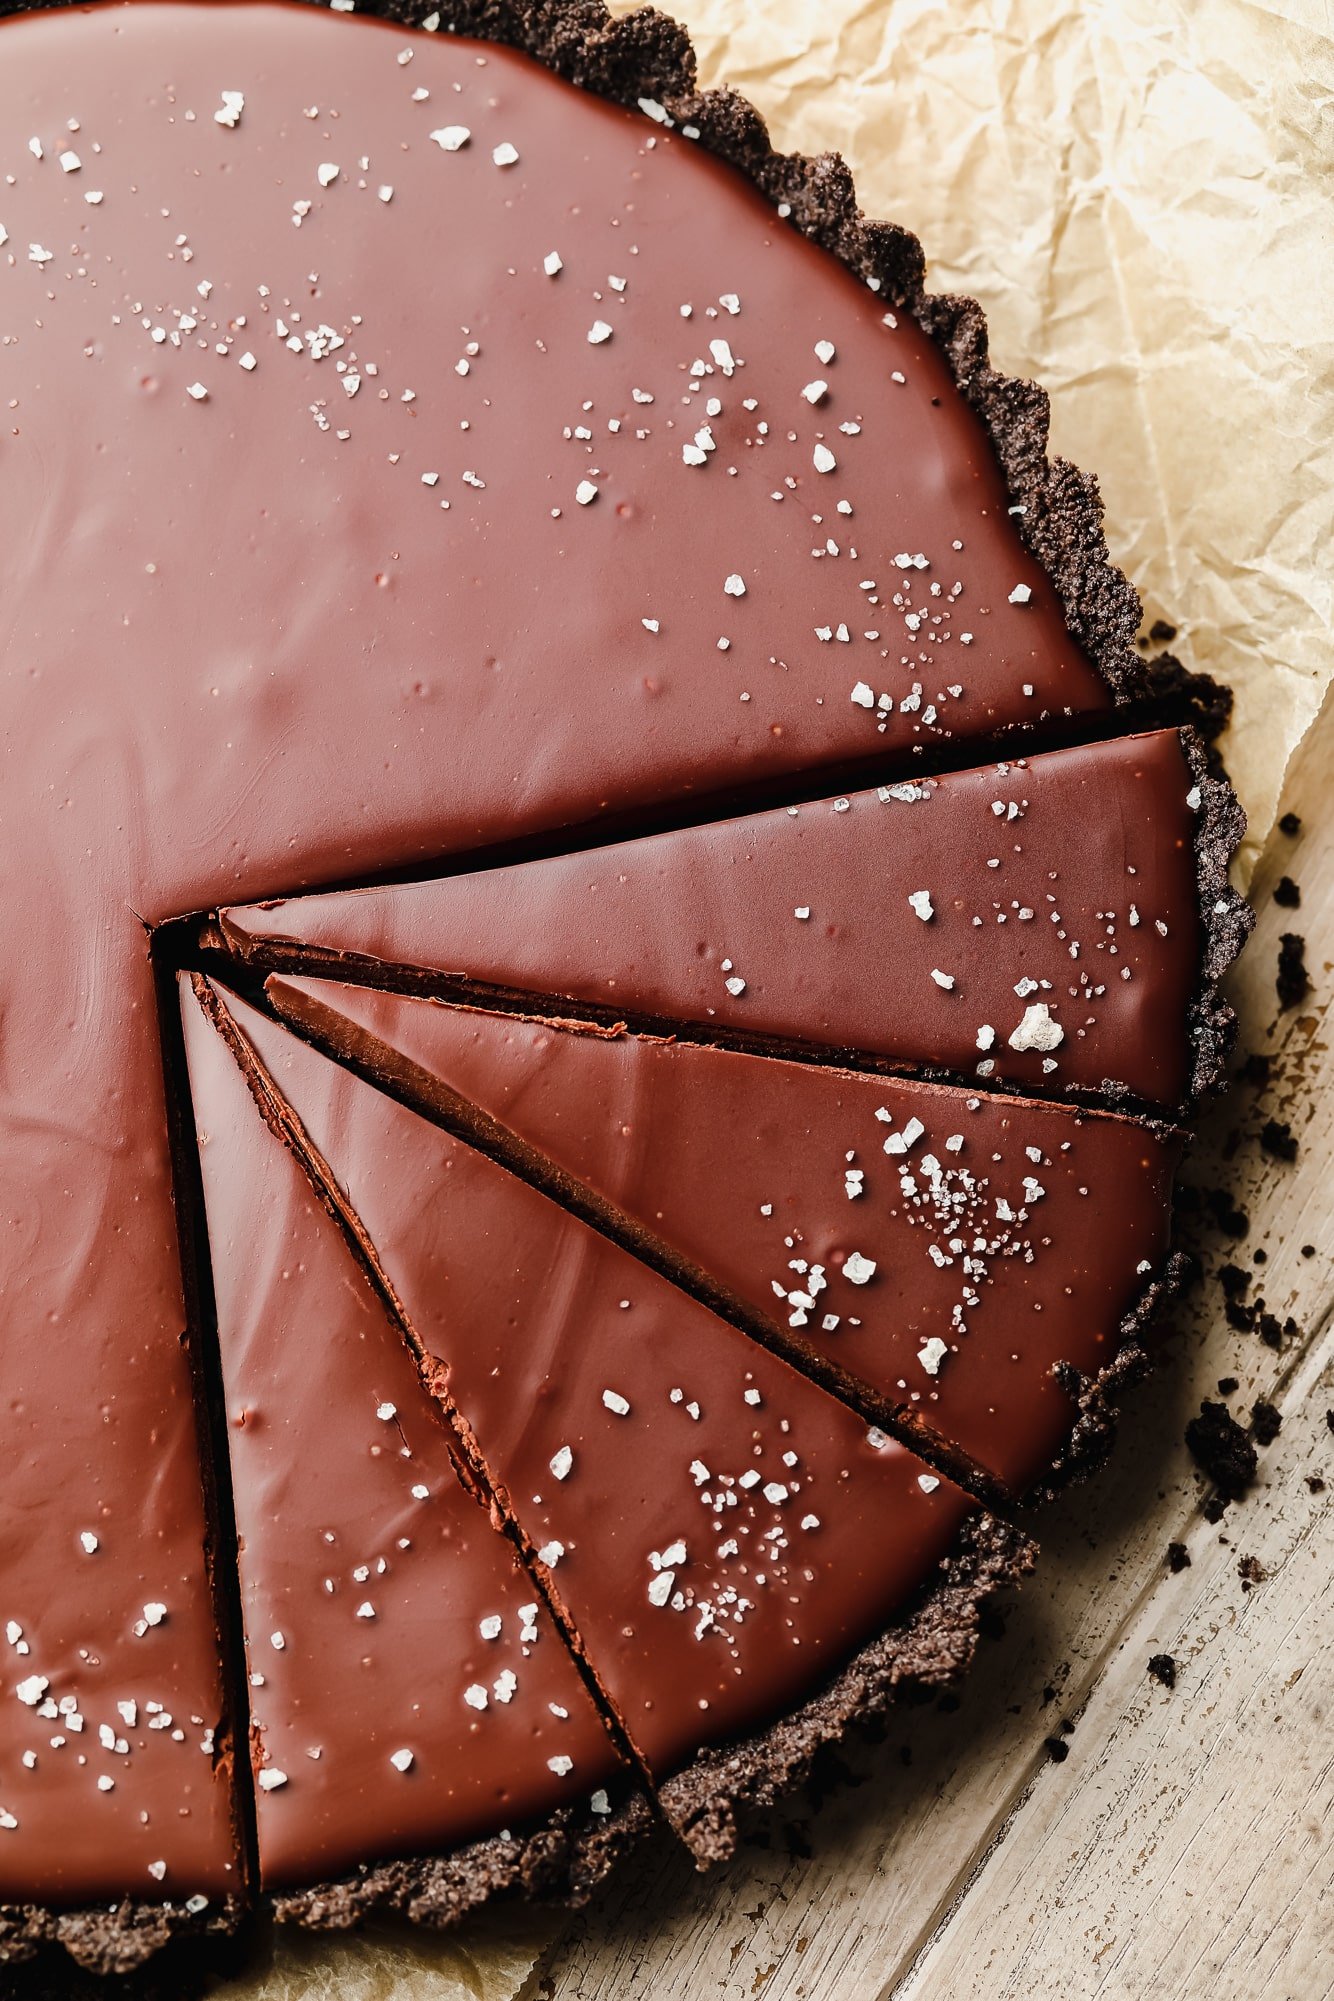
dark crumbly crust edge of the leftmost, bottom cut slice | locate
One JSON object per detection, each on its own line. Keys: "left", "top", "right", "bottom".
{"left": 270, "top": 1793, "right": 652, "bottom": 1931}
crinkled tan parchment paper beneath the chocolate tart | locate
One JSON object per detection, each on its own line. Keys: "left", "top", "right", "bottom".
{"left": 214, "top": 0, "right": 1334, "bottom": 2001}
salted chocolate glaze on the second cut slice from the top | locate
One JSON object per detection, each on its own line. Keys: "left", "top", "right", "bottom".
{"left": 268, "top": 976, "right": 1180, "bottom": 1493}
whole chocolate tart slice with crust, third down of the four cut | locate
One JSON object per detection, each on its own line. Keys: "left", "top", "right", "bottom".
{"left": 198, "top": 984, "right": 1030, "bottom": 1859}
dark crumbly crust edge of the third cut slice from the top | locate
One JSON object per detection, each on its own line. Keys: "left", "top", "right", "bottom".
{"left": 658, "top": 1515, "right": 1038, "bottom": 1869}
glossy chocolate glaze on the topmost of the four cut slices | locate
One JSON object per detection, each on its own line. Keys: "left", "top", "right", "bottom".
{"left": 224, "top": 730, "right": 1200, "bottom": 1107}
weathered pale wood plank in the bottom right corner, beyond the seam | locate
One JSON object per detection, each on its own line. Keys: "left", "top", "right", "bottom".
{"left": 894, "top": 1329, "right": 1334, "bottom": 2001}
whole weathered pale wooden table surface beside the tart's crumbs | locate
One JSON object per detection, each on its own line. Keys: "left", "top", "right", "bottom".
{"left": 524, "top": 712, "right": 1334, "bottom": 2001}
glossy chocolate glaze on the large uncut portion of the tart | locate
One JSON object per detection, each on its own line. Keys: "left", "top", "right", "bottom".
{"left": 0, "top": 0, "right": 1108, "bottom": 1903}
